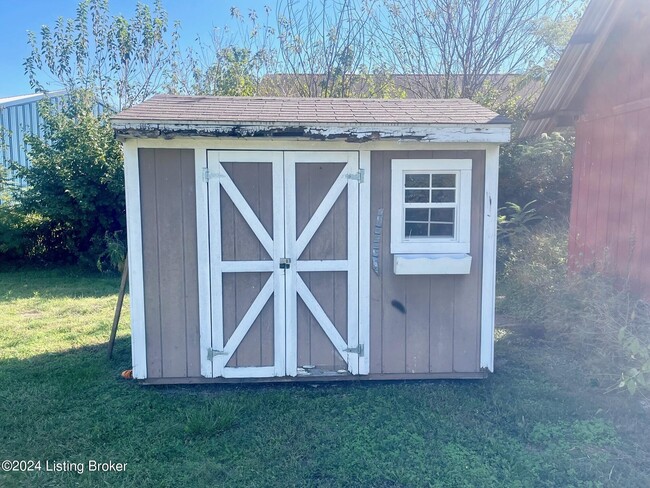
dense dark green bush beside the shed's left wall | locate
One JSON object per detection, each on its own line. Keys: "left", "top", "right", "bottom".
{"left": 15, "top": 92, "right": 126, "bottom": 265}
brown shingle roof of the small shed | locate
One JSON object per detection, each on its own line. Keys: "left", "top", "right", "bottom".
{"left": 112, "top": 95, "right": 511, "bottom": 126}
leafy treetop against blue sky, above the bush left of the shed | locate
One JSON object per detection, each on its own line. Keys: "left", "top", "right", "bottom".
{"left": 24, "top": 0, "right": 178, "bottom": 111}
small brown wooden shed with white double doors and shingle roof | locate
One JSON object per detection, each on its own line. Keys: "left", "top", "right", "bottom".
{"left": 112, "top": 95, "right": 510, "bottom": 383}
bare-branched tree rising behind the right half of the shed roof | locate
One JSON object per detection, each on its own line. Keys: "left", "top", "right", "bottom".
{"left": 375, "top": 0, "right": 584, "bottom": 98}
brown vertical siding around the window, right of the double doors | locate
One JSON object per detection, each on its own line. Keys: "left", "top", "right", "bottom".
{"left": 370, "top": 151, "right": 485, "bottom": 374}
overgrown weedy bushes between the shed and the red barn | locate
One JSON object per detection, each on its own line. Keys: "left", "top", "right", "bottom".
{"left": 497, "top": 223, "right": 650, "bottom": 393}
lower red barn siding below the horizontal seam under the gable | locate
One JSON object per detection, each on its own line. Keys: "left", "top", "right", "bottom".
{"left": 569, "top": 108, "right": 650, "bottom": 298}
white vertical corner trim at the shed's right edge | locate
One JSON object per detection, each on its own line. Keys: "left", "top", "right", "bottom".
{"left": 480, "top": 144, "right": 499, "bottom": 372}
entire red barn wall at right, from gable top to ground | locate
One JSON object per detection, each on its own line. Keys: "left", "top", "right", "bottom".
{"left": 569, "top": 6, "right": 650, "bottom": 299}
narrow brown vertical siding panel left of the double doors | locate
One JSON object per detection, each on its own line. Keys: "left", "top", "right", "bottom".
{"left": 139, "top": 149, "right": 201, "bottom": 378}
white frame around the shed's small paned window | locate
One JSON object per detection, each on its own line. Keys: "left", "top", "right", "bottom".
{"left": 390, "top": 159, "right": 472, "bottom": 254}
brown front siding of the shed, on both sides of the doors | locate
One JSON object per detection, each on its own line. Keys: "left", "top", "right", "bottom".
{"left": 139, "top": 145, "right": 485, "bottom": 383}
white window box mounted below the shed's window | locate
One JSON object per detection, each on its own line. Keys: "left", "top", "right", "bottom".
{"left": 393, "top": 254, "right": 472, "bottom": 275}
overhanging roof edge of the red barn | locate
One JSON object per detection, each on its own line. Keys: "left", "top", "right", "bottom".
{"left": 520, "top": 0, "right": 624, "bottom": 137}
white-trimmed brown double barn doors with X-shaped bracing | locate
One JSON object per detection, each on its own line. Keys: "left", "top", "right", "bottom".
{"left": 204, "top": 151, "right": 367, "bottom": 378}
